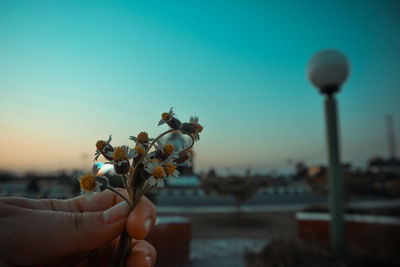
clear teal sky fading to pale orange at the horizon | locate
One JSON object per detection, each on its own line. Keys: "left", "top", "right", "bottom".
{"left": 0, "top": 0, "right": 400, "bottom": 175}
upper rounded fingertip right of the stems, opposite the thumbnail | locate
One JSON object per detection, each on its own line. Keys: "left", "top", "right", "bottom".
{"left": 126, "top": 196, "right": 157, "bottom": 240}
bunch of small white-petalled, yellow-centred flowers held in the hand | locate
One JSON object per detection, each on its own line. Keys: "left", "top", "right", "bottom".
{"left": 79, "top": 108, "right": 203, "bottom": 266}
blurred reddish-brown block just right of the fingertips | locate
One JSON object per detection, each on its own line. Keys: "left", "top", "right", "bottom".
{"left": 146, "top": 216, "right": 191, "bottom": 267}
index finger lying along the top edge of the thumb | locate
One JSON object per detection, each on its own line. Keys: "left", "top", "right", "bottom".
{"left": 0, "top": 188, "right": 128, "bottom": 215}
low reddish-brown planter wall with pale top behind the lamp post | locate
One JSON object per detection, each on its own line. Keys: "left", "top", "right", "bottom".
{"left": 296, "top": 212, "right": 400, "bottom": 255}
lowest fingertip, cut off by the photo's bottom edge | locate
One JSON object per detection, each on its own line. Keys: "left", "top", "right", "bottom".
{"left": 126, "top": 240, "right": 157, "bottom": 267}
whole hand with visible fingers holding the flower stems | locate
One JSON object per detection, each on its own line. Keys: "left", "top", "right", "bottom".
{"left": 0, "top": 190, "right": 157, "bottom": 267}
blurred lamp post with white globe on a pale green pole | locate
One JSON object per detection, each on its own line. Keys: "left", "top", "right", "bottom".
{"left": 307, "top": 50, "right": 350, "bottom": 255}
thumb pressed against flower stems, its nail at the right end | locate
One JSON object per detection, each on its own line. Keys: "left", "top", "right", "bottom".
{"left": 0, "top": 201, "right": 130, "bottom": 264}
